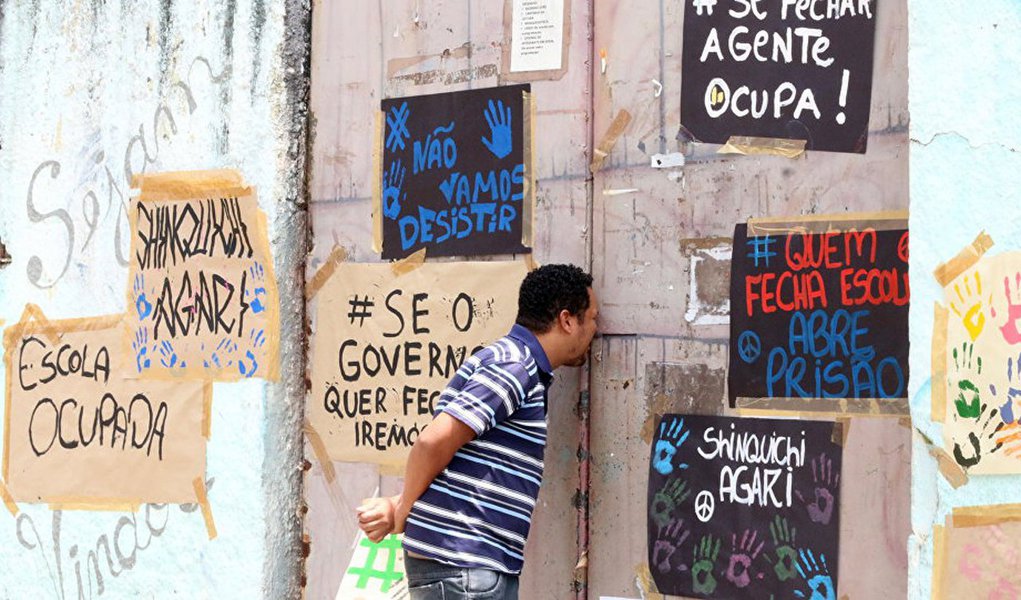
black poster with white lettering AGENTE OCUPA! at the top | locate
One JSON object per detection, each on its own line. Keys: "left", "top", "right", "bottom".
{"left": 681, "top": 0, "right": 876, "bottom": 152}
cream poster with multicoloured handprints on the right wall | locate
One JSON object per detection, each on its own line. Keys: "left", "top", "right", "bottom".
{"left": 933, "top": 252, "right": 1021, "bottom": 474}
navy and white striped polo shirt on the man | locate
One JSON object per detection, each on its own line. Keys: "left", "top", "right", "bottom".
{"left": 404, "top": 324, "right": 552, "bottom": 574}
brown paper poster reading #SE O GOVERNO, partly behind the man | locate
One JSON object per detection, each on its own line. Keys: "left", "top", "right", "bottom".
{"left": 307, "top": 262, "right": 527, "bottom": 467}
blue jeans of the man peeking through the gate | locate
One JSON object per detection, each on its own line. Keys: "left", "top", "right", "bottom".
{"left": 404, "top": 553, "right": 518, "bottom": 600}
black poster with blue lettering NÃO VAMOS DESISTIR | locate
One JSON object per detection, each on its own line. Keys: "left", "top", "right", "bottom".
{"left": 382, "top": 85, "right": 531, "bottom": 258}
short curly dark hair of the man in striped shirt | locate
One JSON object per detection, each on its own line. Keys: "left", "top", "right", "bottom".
{"left": 518, "top": 264, "right": 592, "bottom": 334}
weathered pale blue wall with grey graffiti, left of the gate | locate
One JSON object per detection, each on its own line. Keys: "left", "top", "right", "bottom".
{"left": 0, "top": 0, "right": 308, "bottom": 598}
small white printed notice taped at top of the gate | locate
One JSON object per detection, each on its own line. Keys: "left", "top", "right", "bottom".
{"left": 511, "top": 0, "right": 564, "bottom": 72}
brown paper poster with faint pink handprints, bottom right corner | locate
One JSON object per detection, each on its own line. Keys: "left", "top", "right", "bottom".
{"left": 932, "top": 506, "right": 1021, "bottom": 600}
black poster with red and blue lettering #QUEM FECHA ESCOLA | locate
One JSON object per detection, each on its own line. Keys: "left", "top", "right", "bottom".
{"left": 728, "top": 224, "right": 911, "bottom": 406}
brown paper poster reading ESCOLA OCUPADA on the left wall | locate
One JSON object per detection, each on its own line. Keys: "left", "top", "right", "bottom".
{"left": 3, "top": 306, "right": 211, "bottom": 507}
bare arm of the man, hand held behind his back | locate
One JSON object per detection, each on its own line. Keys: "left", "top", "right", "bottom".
{"left": 357, "top": 412, "right": 475, "bottom": 542}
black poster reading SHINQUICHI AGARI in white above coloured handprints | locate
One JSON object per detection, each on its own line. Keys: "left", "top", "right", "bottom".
{"left": 647, "top": 414, "right": 842, "bottom": 600}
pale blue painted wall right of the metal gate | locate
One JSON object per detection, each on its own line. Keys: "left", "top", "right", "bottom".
{"left": 909, "top": 0, "right": 1021, "bottom": 599}
